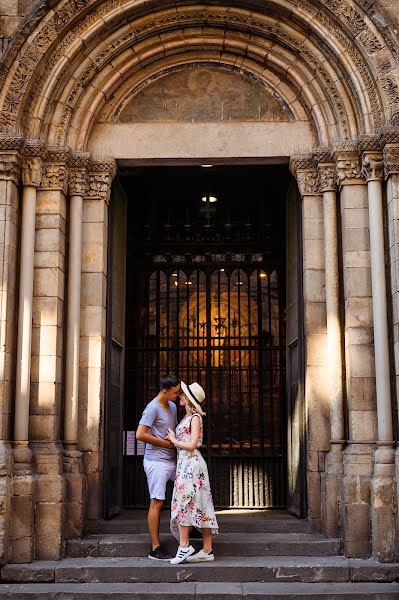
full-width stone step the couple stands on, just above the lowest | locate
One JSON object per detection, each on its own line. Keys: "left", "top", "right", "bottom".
{"left": 1, "top": 547, "right": 399, "bottom": 583}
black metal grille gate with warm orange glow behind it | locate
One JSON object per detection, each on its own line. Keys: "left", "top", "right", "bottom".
{"left": 128, "top": 255, "right": 286, "bottom": 507}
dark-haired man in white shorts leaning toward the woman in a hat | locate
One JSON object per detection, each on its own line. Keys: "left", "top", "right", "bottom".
{"left": 136, "top": 375, "right": 181, "bottom": 560}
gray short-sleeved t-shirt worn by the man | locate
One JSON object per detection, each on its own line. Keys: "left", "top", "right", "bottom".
{"left": 139, "top": 398, "right": 177, "bottom": 461}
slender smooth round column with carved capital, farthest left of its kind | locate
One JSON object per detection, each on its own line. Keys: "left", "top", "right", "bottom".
{"left": 11, "top": 141, "right": 44, "bottom": 563}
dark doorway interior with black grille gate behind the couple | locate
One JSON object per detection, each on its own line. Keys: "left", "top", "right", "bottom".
{"left": 119, "top": 165, "right": 291, "bottom": 508}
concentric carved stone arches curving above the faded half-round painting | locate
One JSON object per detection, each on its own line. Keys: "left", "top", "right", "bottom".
{"left": 0, "top": 0, "right": 399, "bottom": 150}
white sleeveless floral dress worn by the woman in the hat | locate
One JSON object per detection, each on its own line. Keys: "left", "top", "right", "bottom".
{"left": 170, "top": 414, "right": 219, "bottom": 539}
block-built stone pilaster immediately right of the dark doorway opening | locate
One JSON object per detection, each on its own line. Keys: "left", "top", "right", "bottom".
{"left": 290, "top": 155, "right": 330, "bottom": 529}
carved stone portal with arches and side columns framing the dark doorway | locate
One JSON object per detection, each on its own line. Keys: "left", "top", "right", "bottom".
{"left": 0, "top": 0, "right": 399, "bottom": 562}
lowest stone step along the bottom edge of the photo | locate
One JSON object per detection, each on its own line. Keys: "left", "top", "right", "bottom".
{"left": 0, "top": 582, "right": 399, "bottom": 600}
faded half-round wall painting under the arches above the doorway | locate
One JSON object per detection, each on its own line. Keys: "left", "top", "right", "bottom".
{"left": 118, "top": 67, "right": 290, "bottom": 123}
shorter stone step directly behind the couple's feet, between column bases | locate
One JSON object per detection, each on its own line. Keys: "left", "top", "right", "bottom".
{"left": 67, "top": 533, "right": 341, "bottom": 558}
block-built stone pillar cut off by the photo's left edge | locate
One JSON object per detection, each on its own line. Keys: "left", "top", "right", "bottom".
{"left": 0, "top": 137, "right": 22, "bottom": 564}
